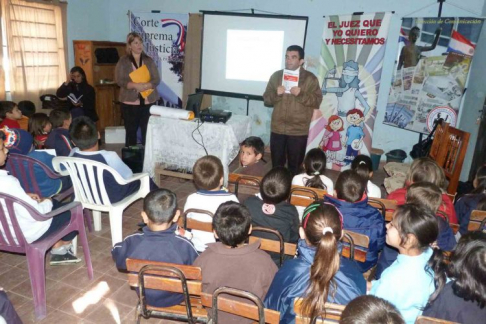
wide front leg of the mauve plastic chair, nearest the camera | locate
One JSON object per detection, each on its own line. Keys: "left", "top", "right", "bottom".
{"left": 26, "top": 248, "right": 47, "bottom": 320}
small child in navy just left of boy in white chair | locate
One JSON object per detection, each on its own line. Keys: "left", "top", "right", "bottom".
{"left": 45, "top": 109, "right": 74, "bottom": 156}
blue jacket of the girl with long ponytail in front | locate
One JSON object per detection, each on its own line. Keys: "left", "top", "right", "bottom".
{"left": 265, "top": 240, "right": 366, "bottom": 324}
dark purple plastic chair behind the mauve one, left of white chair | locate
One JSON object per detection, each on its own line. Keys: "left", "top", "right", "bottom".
{"left": 5, "top": 153, "right": 93, "bottom": 232}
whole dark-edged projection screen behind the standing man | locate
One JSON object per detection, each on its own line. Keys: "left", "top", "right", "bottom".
{"left": 201, "top": 12, "right": 307, "bottom": 99}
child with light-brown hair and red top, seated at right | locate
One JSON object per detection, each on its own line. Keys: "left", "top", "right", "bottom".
{"left": 386, "top": 157, "right": 457, "bottom": 224}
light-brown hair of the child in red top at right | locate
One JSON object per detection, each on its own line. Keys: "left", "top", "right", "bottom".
{"left": 407, "top": 157, "right": 446, "bottom": 189}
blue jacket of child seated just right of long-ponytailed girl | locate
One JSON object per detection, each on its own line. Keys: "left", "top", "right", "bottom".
{"left": 324, "top": 196, "right": 386, "bottom": 272}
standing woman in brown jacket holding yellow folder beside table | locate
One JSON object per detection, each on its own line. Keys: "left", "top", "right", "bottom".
{"left": 115, "top": 32, "right": 160, "bottom": 146}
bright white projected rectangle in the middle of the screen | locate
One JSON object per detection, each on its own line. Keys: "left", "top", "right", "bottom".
{"left": 226, "top": 30, "right": 284, "bottom": 81}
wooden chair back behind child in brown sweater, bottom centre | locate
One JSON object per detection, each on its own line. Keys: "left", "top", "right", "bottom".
{"left": 201, "top": 287, "right": 280, "bottom": 324}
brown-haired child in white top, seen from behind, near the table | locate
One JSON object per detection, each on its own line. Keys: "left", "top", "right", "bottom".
{"left": 184, "top": 155, "right": 238, "bottom": 252}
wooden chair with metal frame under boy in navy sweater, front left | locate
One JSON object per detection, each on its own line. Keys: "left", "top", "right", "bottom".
{"left": 127, "top": 259, "right": 207, "bottom": 323}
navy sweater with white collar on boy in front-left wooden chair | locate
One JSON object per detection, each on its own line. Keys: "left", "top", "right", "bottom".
{"left": 111, "top": 224, "right": 198, "bottom": 307}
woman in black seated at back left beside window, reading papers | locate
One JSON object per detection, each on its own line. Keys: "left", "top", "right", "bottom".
{"left": 56, "top": 66, "right": 99, "bottom": 122}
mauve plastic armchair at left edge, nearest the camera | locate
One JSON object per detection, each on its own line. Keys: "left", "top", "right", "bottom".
{"left": 0, "top": 194, "right": 93, "bottom": 319}
